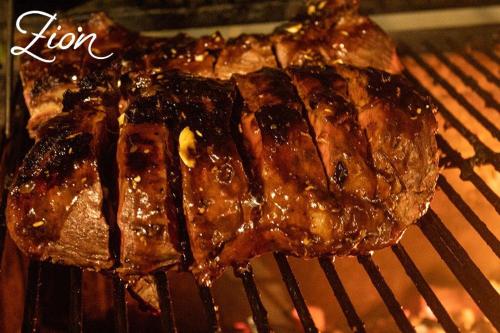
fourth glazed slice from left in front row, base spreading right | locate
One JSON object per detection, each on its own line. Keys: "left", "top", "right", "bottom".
{"left": 230, "top": 69, "right": 401, "bottom": 264}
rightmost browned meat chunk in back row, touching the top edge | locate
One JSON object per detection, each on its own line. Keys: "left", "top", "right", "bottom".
{"left": 273, "top": 0, "right": 402, "bottom": 73}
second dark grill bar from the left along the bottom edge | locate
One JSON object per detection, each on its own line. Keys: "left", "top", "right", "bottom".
{"left": 69, "top": 267, "right": 83, "bottom": 333}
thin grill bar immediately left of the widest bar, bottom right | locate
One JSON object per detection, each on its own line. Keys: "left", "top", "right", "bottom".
{"left": 392, "top": 244, "right": 460, "bottom": 333}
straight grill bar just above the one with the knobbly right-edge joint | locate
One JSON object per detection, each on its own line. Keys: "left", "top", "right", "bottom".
{"left": 403, "top": 44, "right": 500, "bottom": 140}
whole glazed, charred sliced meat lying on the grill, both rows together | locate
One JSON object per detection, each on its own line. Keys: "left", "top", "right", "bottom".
{"left": 7, "top": 0, "right": 438, "bottom": 288}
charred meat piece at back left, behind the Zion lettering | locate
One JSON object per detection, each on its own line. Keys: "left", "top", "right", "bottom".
{"left": 19, "top": 13, "right": 135, "bottom": 138}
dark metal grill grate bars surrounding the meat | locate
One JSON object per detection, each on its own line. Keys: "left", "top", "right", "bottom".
{"left": 0, "top": 5, "right": 500, "bottom": 332}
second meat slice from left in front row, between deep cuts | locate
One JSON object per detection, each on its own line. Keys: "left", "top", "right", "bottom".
{"left": 117, "top": 97, "right": 180, "bottom": 275}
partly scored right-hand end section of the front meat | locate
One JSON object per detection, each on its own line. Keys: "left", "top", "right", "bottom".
{"left": 288, "top": 66, "right": 438, "bottom": 251}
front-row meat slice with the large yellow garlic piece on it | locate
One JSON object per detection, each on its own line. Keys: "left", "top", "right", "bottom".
{"left": 157, "top": 73, "right": 255, "bottom": 284}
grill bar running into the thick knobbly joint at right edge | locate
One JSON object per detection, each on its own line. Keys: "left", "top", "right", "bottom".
{"left": 404, "top": 70, "right": 500, "bottom": 171}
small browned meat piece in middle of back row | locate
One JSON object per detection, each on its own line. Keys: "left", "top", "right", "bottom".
{"left": 215, "top": 34, "right": 277, "bottom": 80}
